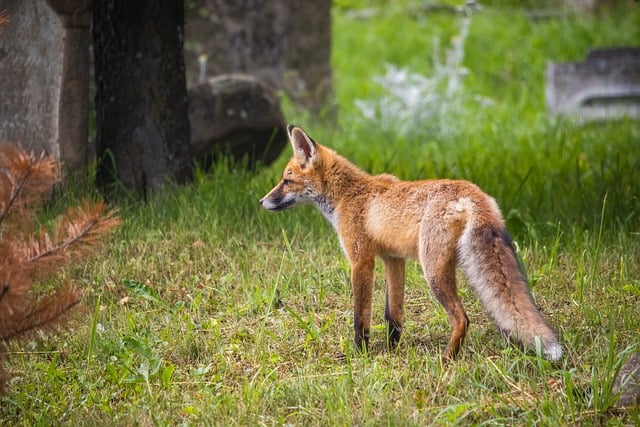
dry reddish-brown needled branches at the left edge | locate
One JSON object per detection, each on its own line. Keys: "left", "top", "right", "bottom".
{"left": 0, "top": 143, "right": 120, "bottom": 389}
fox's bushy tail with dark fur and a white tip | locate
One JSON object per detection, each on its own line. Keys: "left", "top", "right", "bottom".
{"left": 458, "top": 221, "right": 562, "bottom": 360}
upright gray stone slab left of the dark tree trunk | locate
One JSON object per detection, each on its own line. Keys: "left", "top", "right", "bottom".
{"left": 0, "top": 0, "right": 90, "bottom": 174}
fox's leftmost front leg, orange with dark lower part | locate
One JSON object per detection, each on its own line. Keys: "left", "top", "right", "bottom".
{"left": 351, "top": 258, "right": 375, "bottom": 351}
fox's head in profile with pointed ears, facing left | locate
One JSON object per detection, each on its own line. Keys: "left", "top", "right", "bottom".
{"left": 260, "top": 125, "right": 328, "bottom": 214}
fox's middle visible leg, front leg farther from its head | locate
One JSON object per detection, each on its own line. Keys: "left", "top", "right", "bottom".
{"left": 382, "top": 257, "right": 405, "bottom": 348}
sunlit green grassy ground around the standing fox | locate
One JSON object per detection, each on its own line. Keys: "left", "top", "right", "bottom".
{"left": 0, "top": 2, "right": 640, "bottom": 425}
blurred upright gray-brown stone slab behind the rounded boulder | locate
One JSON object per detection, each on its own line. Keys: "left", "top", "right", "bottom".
{"left": 185, "top": 0, "right": 333, "bottom": 113}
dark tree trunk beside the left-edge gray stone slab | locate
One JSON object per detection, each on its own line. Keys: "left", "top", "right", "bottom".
{"left": 93, "top": 0, "right": 192, "bottom": 195}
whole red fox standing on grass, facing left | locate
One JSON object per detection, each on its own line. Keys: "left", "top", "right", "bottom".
{"left": 260, "top": 125, "right": 562, "bottom": 361}
